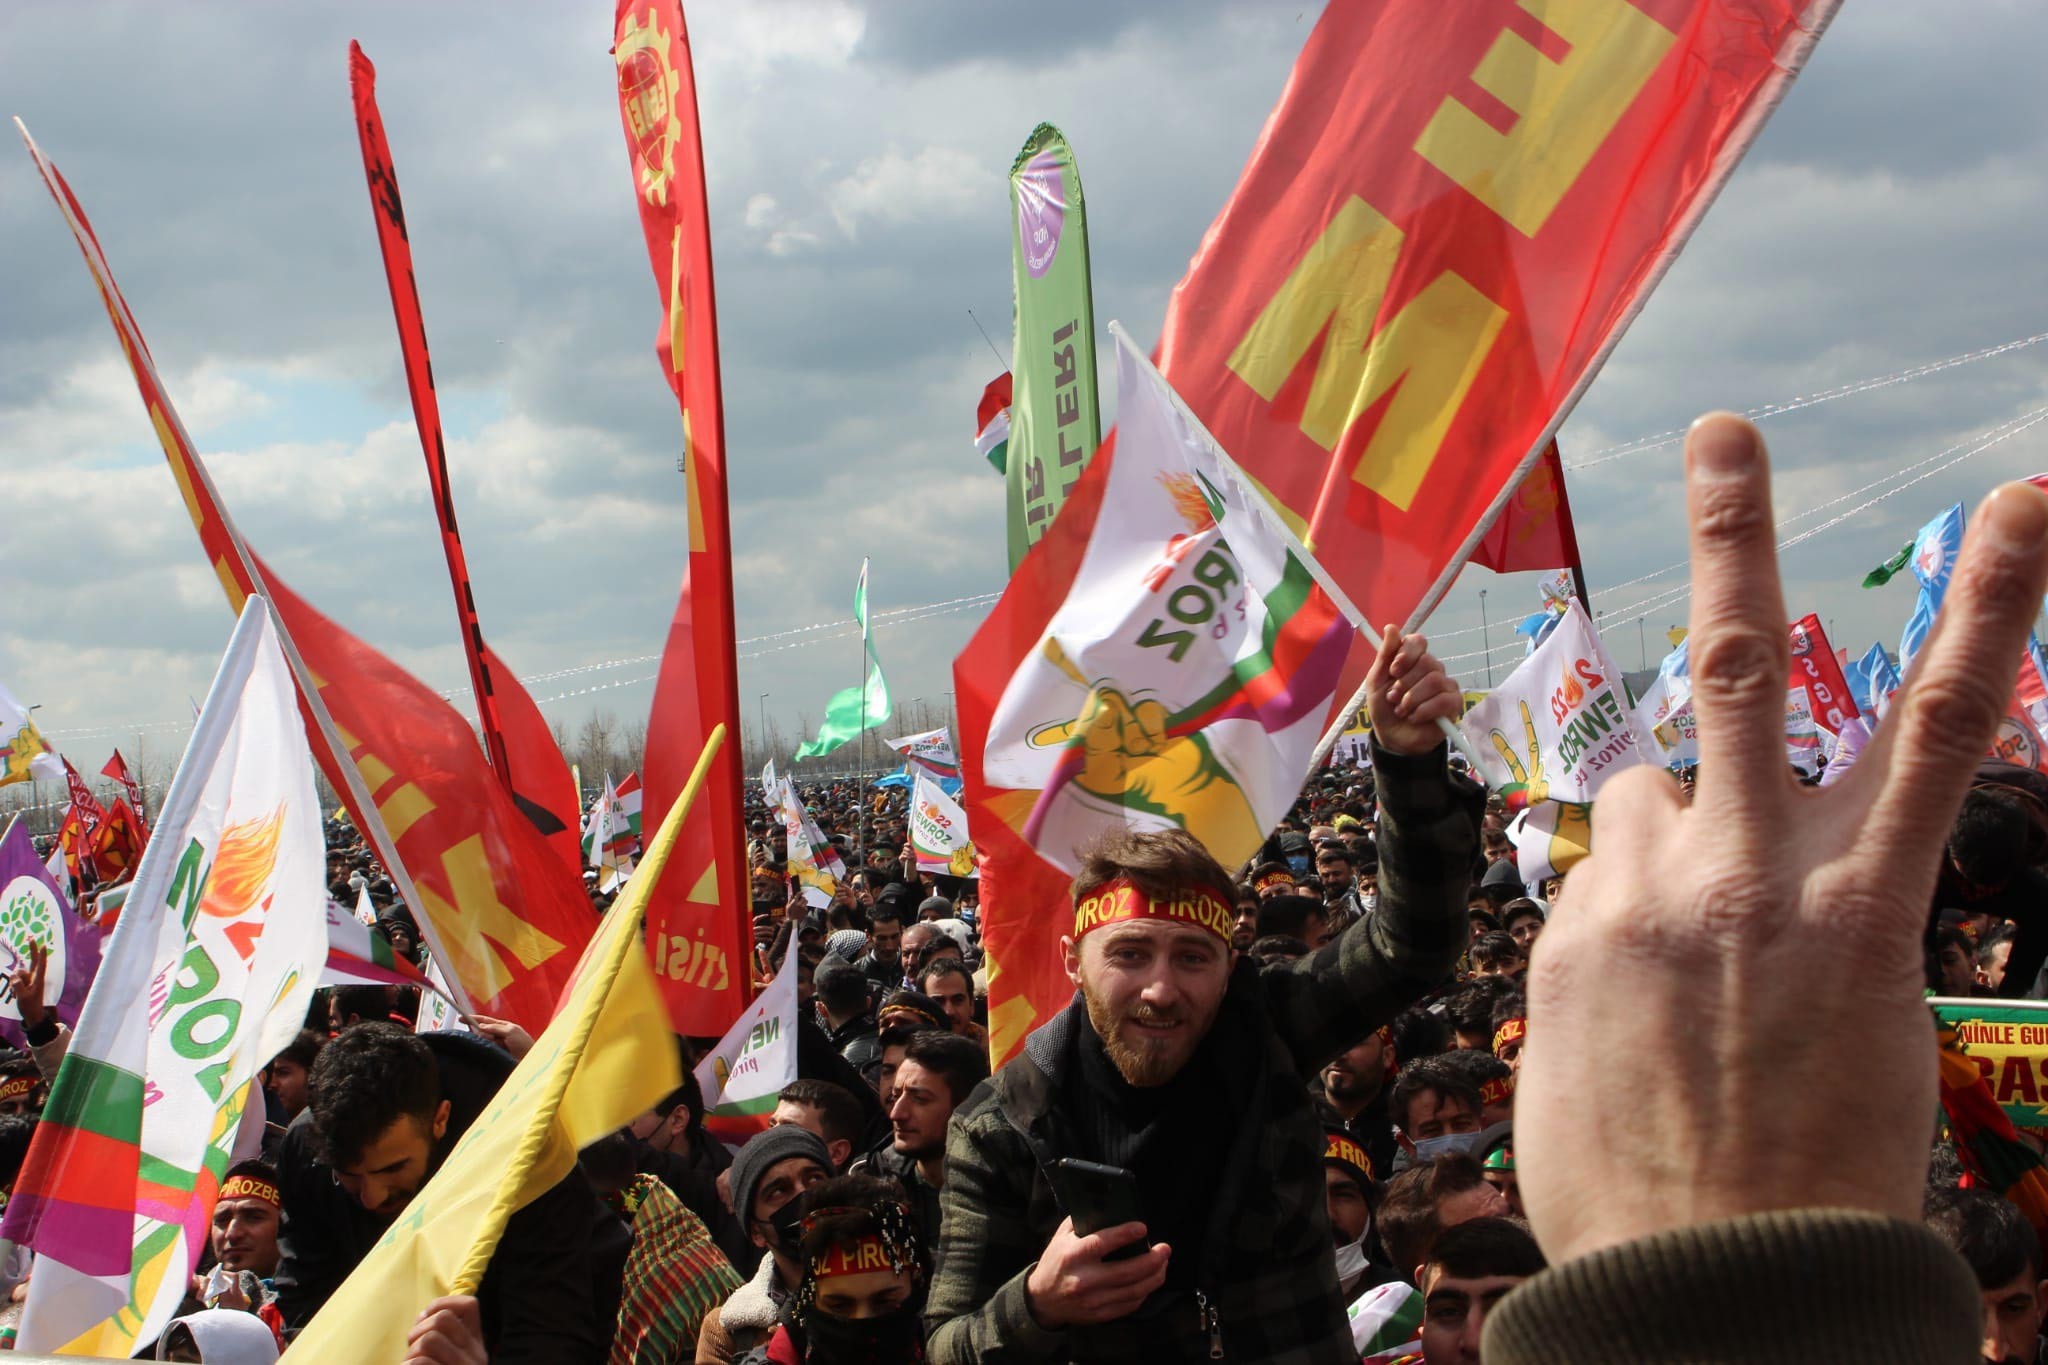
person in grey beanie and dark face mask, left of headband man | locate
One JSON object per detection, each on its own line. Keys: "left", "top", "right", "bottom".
{"left": 696, "top": 1124, "right": 831, "bottom": 1365}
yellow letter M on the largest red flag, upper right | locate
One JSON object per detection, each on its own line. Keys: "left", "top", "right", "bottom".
{"left": 1229, "top": 194, "right": 1507, "bottom": 512}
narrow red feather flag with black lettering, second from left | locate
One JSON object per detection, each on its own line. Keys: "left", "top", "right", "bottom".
{"left": 348, "top": 43, "right": 584, "bottom": 878}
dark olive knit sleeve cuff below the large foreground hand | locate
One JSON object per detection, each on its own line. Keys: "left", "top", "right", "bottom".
{"left": 1485, "top": 1209, "right": 1980, "bottom": 1365}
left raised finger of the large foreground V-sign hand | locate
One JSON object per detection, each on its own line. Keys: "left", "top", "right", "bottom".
{"left": 1686, "top": 413, "right": 1792, "bottom": 829}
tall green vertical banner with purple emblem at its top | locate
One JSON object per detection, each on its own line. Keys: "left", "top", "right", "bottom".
{"left": 1004, "top": 123, "right": 1102, "bottom": 569}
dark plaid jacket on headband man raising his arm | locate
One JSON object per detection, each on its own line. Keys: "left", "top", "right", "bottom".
{"left": 926, "top": 747, "right": 1483, "bottom": 1365}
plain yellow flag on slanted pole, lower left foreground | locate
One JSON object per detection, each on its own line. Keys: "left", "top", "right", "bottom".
{"left": 285, "top": 726, "right": 725, "bottom": 1361}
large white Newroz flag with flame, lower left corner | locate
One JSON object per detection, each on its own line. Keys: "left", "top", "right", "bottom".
{"left": 0, "top": 596, "right": 323, "bottom": 1357}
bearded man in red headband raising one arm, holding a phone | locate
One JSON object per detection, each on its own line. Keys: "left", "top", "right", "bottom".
{"left": 926, "top": 630, "right": 1483, "bottom": 1363}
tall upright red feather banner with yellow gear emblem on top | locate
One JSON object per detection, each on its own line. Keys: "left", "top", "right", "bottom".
{"left": 612, "top": 0, "right": 754, "bottom": 1036}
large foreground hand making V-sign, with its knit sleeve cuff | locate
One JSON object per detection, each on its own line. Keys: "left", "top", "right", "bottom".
{"left": 1487, "top": 413, "right": 2048, "bottom": 1361}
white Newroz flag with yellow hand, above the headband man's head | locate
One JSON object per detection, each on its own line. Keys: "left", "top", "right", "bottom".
{"left": 983, "top": 332, "right": 1356, "bottom": 872}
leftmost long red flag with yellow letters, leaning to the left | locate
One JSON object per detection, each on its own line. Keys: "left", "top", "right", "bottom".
{"left": 23, "top": 122, "right": 596, "bottom": 1033}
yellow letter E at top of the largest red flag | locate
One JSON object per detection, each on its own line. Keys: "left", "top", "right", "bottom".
{"left": 1415, "top": 0, "right": 1677, "bottom": 237}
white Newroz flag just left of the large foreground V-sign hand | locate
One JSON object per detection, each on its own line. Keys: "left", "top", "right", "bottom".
{"left": 1458, "top": 600, "right": 1657, "bottom": 804}
